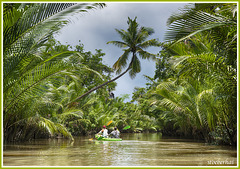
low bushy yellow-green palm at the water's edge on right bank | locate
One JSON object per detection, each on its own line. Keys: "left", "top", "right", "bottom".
{"left": 152, "top": 79, "right": 217, "bottom": 140}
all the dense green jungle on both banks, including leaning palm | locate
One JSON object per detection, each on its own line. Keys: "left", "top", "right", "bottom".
{"left": 3, "top": 3, "right": 237, "bottom": 145}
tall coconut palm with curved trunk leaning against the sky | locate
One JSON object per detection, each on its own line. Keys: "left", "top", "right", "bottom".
{"left": 69, "top": 17, "right": 161, "bottom": 101}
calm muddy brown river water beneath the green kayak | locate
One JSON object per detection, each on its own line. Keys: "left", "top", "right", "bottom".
{"left": 3, "top": 133, "right": 237, "bottom": 166}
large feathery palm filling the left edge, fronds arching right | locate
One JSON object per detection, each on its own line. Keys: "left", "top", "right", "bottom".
{"left": 3, "top": 3, "right": 103, "bottom": 140}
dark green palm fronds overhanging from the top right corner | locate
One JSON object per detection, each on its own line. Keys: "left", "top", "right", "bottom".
{"left": 165, "top": 3, "right": 237, "bottom": 68}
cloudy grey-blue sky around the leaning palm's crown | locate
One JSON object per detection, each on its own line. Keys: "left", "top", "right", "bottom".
{"left": 56, "top": 2, "right": 186, "bottom": 101}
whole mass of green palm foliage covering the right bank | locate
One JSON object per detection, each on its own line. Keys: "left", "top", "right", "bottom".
{"left": 145, "top": 4, "right": 237, "bottom": 145}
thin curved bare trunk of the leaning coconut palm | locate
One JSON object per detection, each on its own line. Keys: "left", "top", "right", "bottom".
{"left": 64, "top": 55, "right": 135, "bottom": 106}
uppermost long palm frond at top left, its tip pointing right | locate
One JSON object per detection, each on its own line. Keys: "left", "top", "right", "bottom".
{"left": 3, "top": 3, "right": 101, "bottom": 51}
